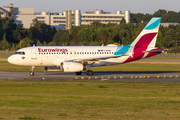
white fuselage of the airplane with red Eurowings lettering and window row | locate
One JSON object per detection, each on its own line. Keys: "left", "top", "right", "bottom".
{"left": 8, "top": 46, "right": 129, "bottom": 66}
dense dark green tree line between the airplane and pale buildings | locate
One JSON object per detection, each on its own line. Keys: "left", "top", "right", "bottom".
{"left": 0, "top": 10, "right": 180, "bottom": 52}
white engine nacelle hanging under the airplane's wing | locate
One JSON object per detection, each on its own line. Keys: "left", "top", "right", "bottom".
{"left": 60, "top": 62, "right": 86, "bottom": 72}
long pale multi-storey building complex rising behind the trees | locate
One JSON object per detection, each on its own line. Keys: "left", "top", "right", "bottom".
{"left": 0, "top": 4, "right": 130, "bottom": 30}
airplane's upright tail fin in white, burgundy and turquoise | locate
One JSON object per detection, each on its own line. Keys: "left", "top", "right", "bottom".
{"left": 125, "top": 17, "right": 161, "bottom": 62}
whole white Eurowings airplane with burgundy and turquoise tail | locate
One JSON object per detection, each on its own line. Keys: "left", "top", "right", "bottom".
{"left": 8, "top": 17, "right": 165, "bottom": 76}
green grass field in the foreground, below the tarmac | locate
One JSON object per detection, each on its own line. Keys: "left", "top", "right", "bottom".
{"left": 0, "top": 80, "right": 180, "bottom": 120}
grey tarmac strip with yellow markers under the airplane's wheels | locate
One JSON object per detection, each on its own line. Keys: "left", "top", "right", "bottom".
{"left": 0, "top": 71, "right": 180, "bottom": 83}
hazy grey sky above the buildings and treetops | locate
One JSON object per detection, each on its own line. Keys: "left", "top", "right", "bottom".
{"left": 0, "top": 0, "right": 180, "bottom": 14}
